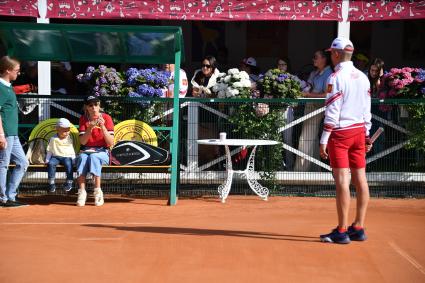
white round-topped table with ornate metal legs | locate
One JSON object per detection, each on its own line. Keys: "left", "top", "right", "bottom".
{"left": 197, "top": 139, "right": 279, "bottom": 203}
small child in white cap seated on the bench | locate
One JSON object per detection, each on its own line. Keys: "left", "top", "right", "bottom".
{"left": 46, "top": 118, "right": 75, "bottom": 193}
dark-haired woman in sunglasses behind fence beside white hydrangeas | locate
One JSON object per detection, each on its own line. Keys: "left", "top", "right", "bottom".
{"left": 190, "top": 55, "right": 220, "bottom": 97}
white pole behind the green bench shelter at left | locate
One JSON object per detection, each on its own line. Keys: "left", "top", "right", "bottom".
{"left": 37, "top": 0, "right": 51, "bottom": 121}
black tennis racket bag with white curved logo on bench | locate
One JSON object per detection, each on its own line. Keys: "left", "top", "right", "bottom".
{"left": 111, "top": 141, "right": 169, "bottom": 165}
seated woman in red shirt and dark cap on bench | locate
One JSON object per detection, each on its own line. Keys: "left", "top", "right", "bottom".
{"left": 77, "top": 96, "right": 114, "bottom": 206}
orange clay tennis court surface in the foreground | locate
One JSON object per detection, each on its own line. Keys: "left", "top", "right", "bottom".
{"left": 0, "top": 195, "right": 425, "bottom": 283}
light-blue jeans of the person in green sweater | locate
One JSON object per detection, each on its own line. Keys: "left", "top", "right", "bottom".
{"left": 0, "top": 136, "right": 29, "bottom": 202}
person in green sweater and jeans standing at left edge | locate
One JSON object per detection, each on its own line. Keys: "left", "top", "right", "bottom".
{"left": 0, "top": 56, "right": 29, "bottom": 207}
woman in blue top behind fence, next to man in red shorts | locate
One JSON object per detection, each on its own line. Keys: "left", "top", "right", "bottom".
{"left": 295, "top": 49, "right": 332, "bottom": 171}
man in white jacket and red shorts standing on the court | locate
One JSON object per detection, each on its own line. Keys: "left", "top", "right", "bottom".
{"left": 320, "top": 37, "right": 372, "bottom": 244}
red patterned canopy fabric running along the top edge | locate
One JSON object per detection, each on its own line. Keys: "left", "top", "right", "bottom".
{"left": 0, "top": 0, "right": 425, "bottom": 21}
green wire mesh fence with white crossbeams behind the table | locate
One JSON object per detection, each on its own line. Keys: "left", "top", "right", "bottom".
{"left": 19, "top": 96, "right": 425, "bottom": 197}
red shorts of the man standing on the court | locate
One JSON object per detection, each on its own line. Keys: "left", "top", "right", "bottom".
{"left": 327, "top": 127, "right": 366, "bottom": 169}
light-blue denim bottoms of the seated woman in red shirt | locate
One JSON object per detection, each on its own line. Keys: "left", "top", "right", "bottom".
{"left": 77, "top": 150, "right": 109, "bottom": 177}
